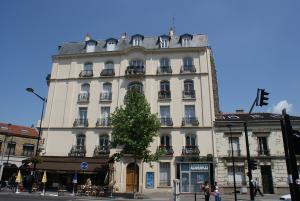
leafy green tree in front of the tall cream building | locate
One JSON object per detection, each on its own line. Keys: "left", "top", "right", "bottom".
{"left": 110, "top": 91, "right": 160, "bottom": 192}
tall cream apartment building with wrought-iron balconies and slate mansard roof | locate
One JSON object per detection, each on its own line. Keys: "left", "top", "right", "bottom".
{"left": 38, "top": 30, "right": 219, "bottom": 192}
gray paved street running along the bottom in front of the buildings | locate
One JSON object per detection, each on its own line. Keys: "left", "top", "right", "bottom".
{"left": 0, "top": 193, "right": 280, "bottom": 201}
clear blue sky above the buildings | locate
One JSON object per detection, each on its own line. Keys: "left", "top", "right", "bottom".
{"left": 0, "top": 0, "right": 300, "bottom": 126}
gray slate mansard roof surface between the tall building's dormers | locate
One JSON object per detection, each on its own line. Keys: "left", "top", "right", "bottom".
{"left": 58, "top": 34, "right": 208, "bottom": 55}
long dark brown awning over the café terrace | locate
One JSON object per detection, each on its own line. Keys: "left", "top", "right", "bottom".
{"left": 30, "top": 156, "right": 109, "bottom": 172}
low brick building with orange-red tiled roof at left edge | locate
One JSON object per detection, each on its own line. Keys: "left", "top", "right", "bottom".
{"left": 0, "top": 123, "right": 38, "bottom": 181}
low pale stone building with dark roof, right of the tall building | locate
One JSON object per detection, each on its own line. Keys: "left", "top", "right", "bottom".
{"left": 214, "top": 111, "right": 300, "bottom": 194}
